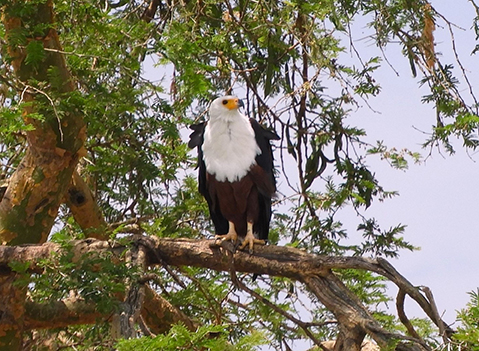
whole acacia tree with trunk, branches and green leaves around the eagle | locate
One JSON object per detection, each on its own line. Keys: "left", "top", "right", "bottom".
{"left": 0, "top": 0, "right": 479, "bottom": 350}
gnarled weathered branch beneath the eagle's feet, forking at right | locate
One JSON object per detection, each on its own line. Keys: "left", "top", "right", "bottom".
{"left": 0, "top": 236, "right": 453, "bottom": 350}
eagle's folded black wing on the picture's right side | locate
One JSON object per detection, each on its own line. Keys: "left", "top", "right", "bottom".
{"left": 250, "top": 118, "right": 280, "bottom": 240}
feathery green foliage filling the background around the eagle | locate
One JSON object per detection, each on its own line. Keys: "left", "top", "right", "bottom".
{"left": 0, "top": 0, "right": 479, "bottom": 350}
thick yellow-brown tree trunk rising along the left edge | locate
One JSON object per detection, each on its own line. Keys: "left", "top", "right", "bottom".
{"left": 0, "top": 0, "right": 85, "bottom": 350}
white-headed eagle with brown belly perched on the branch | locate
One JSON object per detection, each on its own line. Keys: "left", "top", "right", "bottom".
{"left": 188, "top": 95, "right": 279, "bottom": 253}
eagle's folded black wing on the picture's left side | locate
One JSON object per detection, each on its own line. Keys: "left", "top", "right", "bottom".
{"left": 188, "top": 122, "right": 229, "bottom": 234}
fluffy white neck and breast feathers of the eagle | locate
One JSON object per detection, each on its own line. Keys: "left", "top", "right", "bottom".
{"left": 202, "top": 110, "right": 261, "bottom": 182}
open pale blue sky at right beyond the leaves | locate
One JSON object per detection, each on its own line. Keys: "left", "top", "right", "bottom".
{"left": 344, "top": 0, "right": 479, "bottom": 323}
